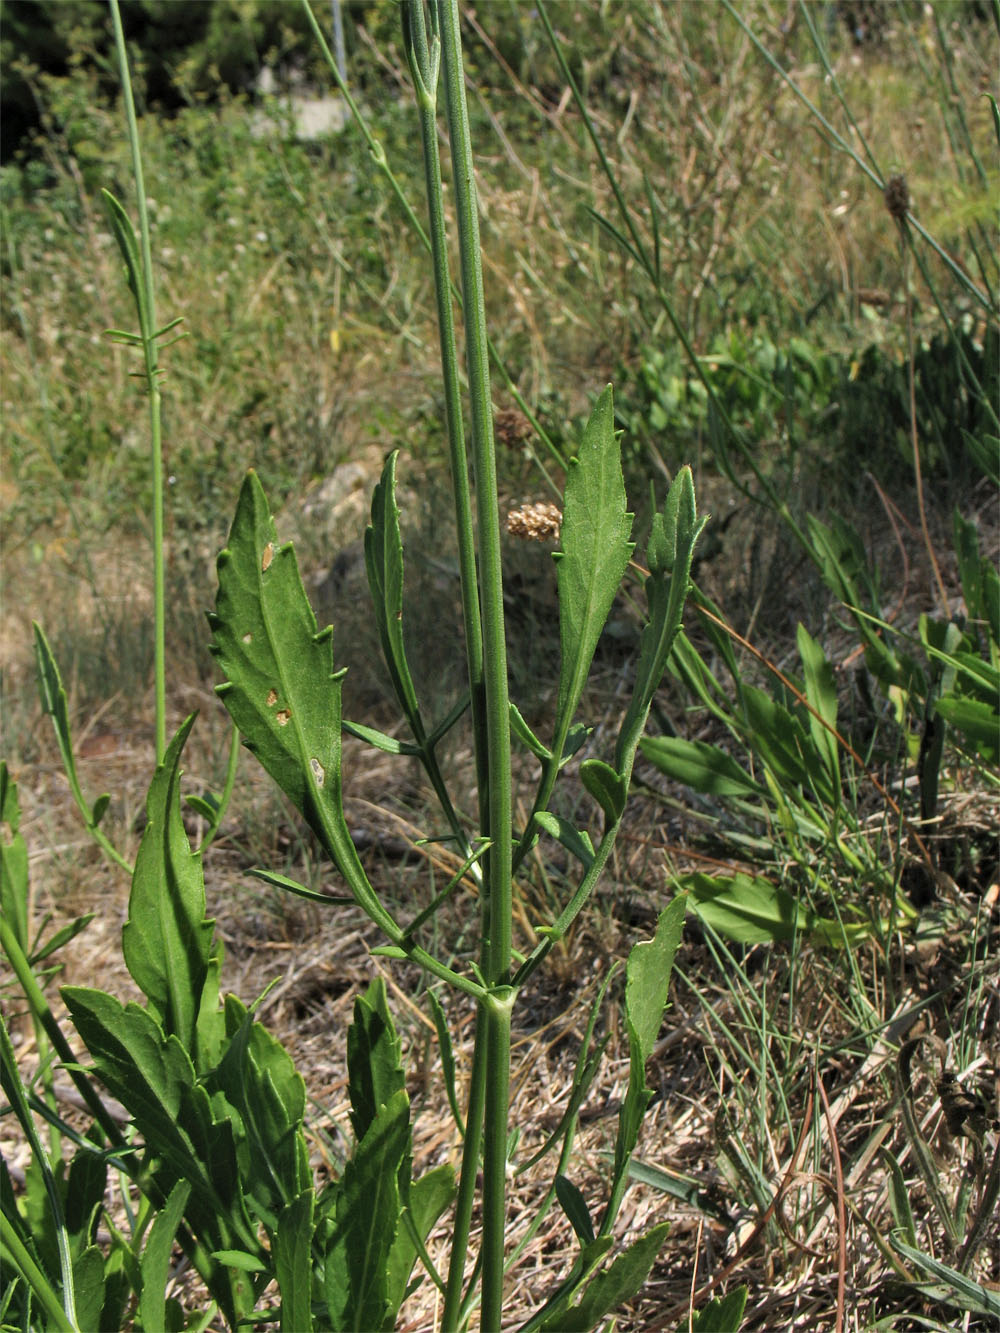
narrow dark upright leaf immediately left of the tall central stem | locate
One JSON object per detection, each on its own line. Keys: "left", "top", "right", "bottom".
{"left": 364, "top": 451, "right": 423, "bottom": 737}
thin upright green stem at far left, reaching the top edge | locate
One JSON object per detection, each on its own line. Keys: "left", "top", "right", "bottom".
{"left": 109, "top": 0, "right": 167, "bottom": 764}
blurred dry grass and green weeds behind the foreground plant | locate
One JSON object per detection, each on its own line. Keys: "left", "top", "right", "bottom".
{"left": 0, "top": 0, "right": 1000, "bottom": 1328}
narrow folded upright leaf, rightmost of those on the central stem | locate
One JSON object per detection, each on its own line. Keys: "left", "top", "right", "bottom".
{"left": 615, "top": 468, "right": 707, "bottom": 780}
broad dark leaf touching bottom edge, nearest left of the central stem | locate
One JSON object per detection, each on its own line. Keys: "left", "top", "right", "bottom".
{"left": 325, "top": 1089, "right": 409, "bottom": 1333}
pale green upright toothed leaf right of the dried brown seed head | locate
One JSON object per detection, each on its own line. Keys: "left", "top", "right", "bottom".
{"left": 556, "top": 385, "right": 633, "bottom": 737}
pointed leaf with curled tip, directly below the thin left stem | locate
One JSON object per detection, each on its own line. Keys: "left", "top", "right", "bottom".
{"left": 121, "top": 716, "right": 215, "bottom": 1052}
